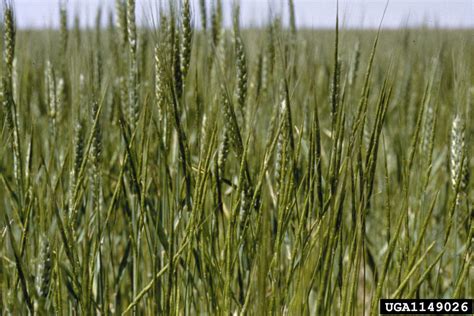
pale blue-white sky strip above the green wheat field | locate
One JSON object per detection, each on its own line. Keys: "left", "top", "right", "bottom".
{"left": 12, "top": 0, "right": 474, "bottom": 28}
